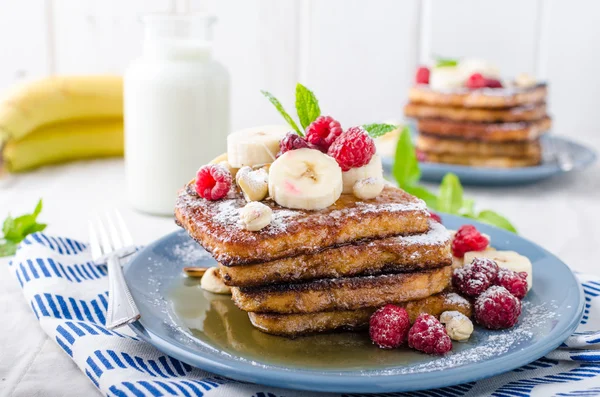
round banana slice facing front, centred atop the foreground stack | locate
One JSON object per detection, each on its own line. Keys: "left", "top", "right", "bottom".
{"left": 269, "top": 149, "right": 343, "bottom": 210}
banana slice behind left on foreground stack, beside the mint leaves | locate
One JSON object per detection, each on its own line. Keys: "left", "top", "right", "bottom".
{"left": 227, "top": 125, "right": 290, "bottom": 168}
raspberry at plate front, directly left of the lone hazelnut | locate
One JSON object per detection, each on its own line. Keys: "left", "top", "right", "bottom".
{"left": 408, "top": 313, "right": 452, "bottom": 355}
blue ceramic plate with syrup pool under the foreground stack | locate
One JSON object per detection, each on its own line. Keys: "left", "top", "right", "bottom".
{"left": 125, "top": 215, "right": 583, "bottom": 393}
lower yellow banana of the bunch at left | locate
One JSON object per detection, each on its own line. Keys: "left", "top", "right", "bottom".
{"left": 1, "top": 118, "right": 124, "bottom": 172}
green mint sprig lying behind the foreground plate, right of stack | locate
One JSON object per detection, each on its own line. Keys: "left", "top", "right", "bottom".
{"left": 392, "top": 127, "right": 517, "bottom": 233}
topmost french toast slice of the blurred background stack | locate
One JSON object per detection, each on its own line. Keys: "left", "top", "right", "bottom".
{"left": 408, "top": 83, "right": 548, "bottom": 109}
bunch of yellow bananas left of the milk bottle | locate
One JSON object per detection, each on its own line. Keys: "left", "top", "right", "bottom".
{"left": 0, "top": 76, "right": 123, "bottom": 172}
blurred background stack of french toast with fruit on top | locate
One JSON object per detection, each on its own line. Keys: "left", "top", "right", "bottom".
{"left": 404, "top": 59, "right": 551, "bottom": 168}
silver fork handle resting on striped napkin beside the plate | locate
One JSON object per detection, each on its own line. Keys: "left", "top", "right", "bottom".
{"left": 106, "top": 257, "right": 140, "bottom": 329}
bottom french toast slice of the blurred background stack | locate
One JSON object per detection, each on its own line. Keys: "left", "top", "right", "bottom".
{"left": 423, "top": 151, "right": 542, "bottom": 168}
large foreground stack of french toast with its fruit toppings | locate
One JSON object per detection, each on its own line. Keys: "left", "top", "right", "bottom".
{"left": 175, "top": 123, "right": 472, "bottom": 337}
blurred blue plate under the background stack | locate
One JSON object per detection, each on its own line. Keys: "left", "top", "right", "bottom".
{"left": 383, "top": 136, "right": 596, "bottom": 186}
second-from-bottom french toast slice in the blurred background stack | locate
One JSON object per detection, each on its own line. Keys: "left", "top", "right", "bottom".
{"left": 416, "top": 134, "right": 542, "bottom": 158}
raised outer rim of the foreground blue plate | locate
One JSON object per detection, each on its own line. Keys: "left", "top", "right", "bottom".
{"left": 126, "top": 214, "right": 585, "bottom": 393}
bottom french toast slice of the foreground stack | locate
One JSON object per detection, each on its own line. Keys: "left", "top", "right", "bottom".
{"left": 248, "top": 292, "right": 473, "bottom": 337}
